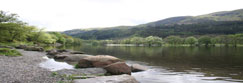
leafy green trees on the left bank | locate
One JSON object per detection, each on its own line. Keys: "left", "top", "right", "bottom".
{"left": 0, "top": 11, "right": 82, "bottom": 44}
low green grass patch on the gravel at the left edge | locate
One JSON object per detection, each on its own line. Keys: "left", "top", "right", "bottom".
{"left": 0, "top": 48, "right": 22, "bottom": 56}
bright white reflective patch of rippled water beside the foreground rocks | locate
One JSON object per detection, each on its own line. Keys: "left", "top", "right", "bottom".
{"left": 132, "top": 67, "right": 242, "bottom": 83}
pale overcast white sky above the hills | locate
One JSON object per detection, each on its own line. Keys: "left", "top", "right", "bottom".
{"left": 0, "top": 0, "right": 243, "bottom": 31}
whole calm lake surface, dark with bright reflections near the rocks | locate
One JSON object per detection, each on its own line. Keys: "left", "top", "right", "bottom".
{"left": 65, "top": 46, "right": 243, "bottom": 83}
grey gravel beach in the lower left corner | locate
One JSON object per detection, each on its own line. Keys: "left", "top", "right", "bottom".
{"left": 0, "top": 49, "right": 61, "bottom": 83}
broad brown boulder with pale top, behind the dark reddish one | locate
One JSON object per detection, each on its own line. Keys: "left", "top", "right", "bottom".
{"left": 77, "top": 55, "right": 122, "bottom": 68}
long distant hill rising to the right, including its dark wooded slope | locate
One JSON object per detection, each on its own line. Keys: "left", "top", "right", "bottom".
{"left": 63, "top": 9, "right": 243, "bottom": 40}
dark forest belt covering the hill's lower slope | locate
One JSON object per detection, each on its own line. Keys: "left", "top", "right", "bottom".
{"left": 64, "top": 21, "right": 243, "bottom": 40}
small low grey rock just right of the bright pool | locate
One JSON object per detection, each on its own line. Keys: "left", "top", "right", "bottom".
{"left": 63, "top": 54, "right": 91, "bottom": 62}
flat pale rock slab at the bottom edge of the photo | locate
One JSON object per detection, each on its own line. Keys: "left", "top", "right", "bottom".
{"left": 73, "top": 75, "right": 139, "bottom": 83}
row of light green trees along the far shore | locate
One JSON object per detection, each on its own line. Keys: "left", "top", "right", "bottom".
{"left": 86, "top": 34, "right": 243, "bottom": 47}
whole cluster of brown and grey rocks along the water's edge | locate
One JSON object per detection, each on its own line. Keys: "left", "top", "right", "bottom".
{"left": 16, "top": 45, "right": 147, "bottom": 83}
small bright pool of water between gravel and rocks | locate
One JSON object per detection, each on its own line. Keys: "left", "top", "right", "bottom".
{"left": 39, "top": 56, "right": 74, "bottom": 71}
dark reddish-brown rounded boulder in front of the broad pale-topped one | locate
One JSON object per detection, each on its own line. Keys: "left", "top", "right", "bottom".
{"left": 104, "top": 62, "right": 131, "bottom": 75}
